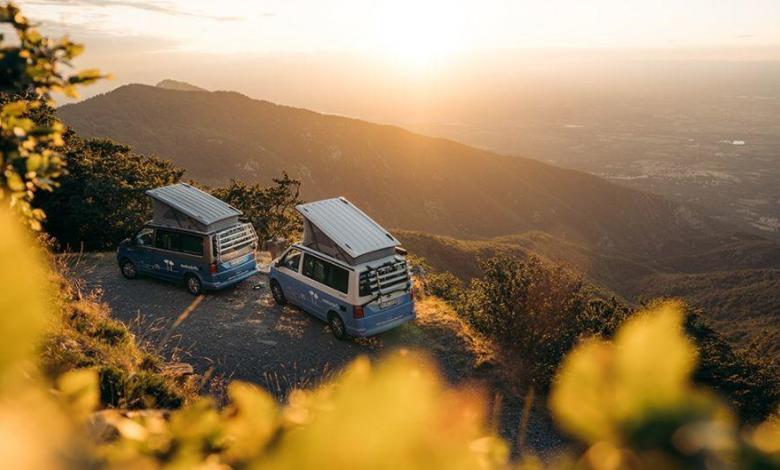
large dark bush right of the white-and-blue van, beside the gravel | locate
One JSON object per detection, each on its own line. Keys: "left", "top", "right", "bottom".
{"left": 461, "top": 256, "right": 596, "bottom": 388}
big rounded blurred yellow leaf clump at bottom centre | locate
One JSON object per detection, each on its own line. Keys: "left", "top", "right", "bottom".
{"left": 262, "top": 354, "right": 507, "bottom": 469}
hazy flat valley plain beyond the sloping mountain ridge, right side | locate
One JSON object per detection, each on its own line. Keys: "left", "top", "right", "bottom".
{"left": 397, "top": 61, "right": 780, "bottom": 237}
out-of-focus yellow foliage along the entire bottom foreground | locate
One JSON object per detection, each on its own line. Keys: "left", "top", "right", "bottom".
{"left": 0, "top": 205, "right": 780, "bottom": 469}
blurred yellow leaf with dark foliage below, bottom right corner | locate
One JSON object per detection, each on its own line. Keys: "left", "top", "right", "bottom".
{"left": 550, "top": 302, "right": 780, "bottom": 469}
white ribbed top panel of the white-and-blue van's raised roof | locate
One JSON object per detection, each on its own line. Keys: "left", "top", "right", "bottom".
{"left": 296, "top": 197, "right": 401, "bottom": 258}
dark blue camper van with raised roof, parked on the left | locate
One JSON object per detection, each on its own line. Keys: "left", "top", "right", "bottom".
{"left": 116, "top": 183, "right": 258, "bottom": 295}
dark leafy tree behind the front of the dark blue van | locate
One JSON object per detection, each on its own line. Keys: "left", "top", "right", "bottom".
{"left": 35, "top": 134, "right": 184, "bottom": 250}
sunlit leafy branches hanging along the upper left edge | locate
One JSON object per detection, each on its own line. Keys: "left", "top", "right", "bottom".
{"left": 0, "top": 3, "right": 102, "bottom": 229}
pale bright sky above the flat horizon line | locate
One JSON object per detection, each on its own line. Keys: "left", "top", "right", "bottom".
{"left": 19, "top": 0, "right": 780, "bottom": 57}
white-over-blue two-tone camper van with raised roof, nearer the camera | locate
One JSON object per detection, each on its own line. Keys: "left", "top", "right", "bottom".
{"left": 270, "top": 198, "right": 415, "bottom": 339}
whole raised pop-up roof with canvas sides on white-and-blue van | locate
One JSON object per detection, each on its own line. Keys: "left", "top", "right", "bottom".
{"left": 296, "top": 197, "right": 401, "bottom": 266}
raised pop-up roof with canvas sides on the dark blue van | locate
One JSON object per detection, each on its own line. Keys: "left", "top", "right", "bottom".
{"left": 146, "top": 183, "right": 241, "bottom": 233}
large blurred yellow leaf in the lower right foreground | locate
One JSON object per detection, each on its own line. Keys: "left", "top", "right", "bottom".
{"left": 550, "top": 302, "right": 696, "bottom": 443}
